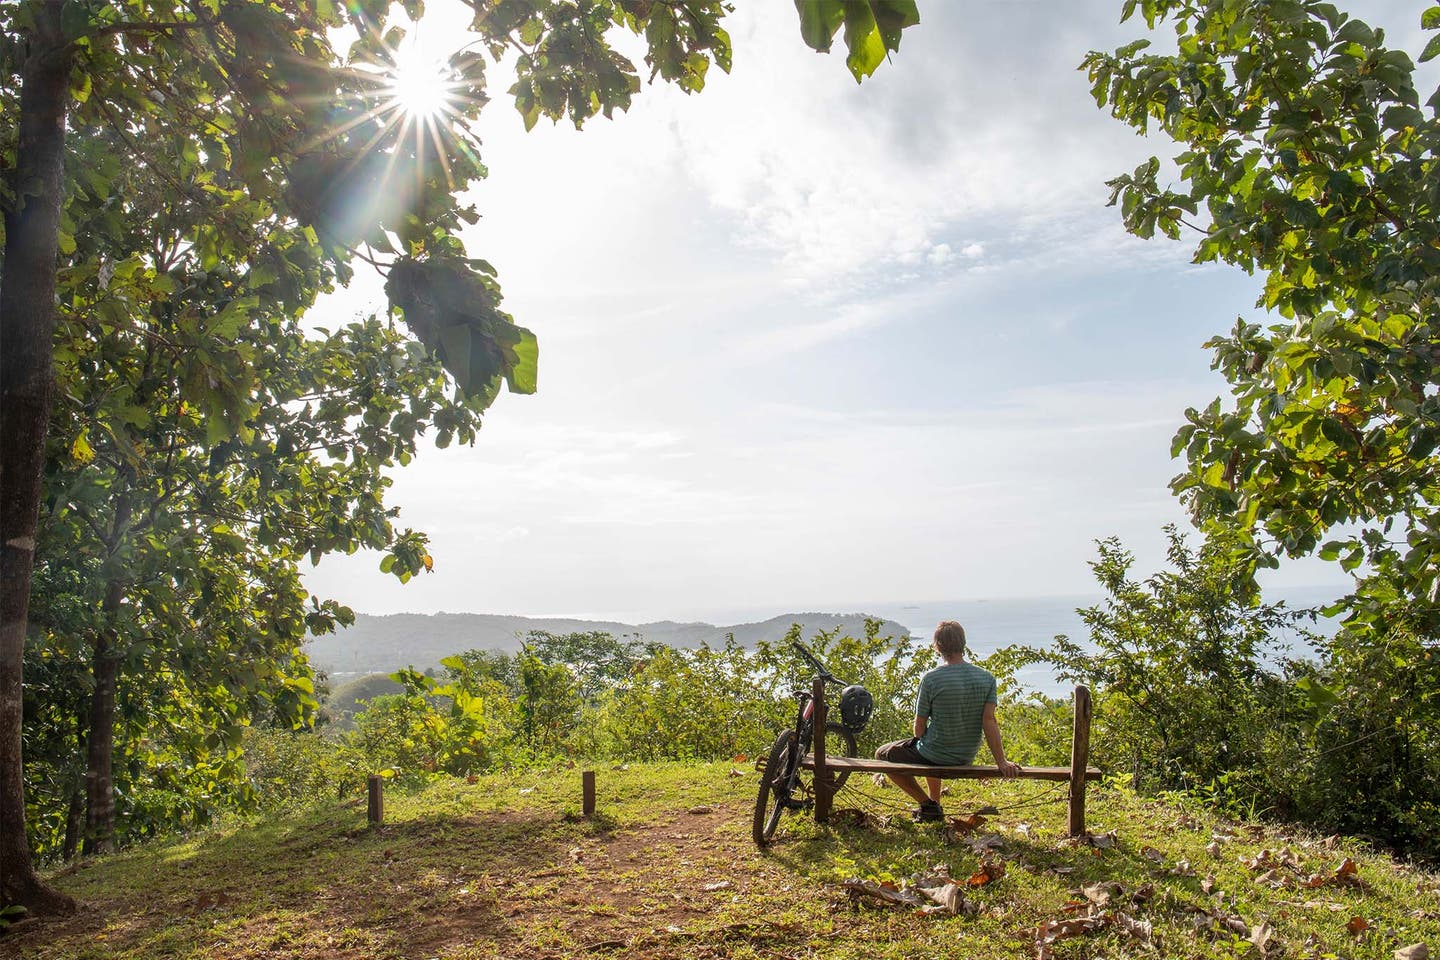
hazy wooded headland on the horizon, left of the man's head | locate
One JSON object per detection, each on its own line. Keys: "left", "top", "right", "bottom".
{"left": 305, "top": 613, "right": 909, "bottom": 678}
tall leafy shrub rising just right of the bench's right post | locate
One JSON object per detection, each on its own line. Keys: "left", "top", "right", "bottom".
{"left": 998, "top": 527, "right": 1297, "bottom": 789}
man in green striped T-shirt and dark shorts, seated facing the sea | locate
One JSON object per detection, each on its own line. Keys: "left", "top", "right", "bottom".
{"left": 876, "top": 620, "right": 1021, "bottom": 822}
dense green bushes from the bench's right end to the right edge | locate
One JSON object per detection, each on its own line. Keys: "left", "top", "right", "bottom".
{"left": 1008, "top": 528, "right": 1440, "bottom": 859}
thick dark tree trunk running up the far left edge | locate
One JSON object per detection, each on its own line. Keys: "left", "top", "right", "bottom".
{"left": 0, "top": 0, "right": 75, "bottom": 914}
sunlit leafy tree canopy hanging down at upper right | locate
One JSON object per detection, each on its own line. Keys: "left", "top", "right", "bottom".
{"left": 1084, "top": 0, "right": 1440, "bottom": 636}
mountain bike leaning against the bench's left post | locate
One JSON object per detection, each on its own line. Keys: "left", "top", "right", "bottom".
{"left": 752, "top": 643, "right": 855, "bottom": 848}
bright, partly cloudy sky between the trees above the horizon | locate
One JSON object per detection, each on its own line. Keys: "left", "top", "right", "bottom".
{"left": 307, "top": 0, "right": 1426, "bottom": 622}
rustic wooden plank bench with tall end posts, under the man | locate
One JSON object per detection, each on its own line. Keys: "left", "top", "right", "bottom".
{"left": 801, "top": 679, "right": 1100, "bottom": 836}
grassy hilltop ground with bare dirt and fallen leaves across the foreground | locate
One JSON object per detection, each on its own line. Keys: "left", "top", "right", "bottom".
{"left": 0, "top": 764, "right": 1440, "bottom": 960}
